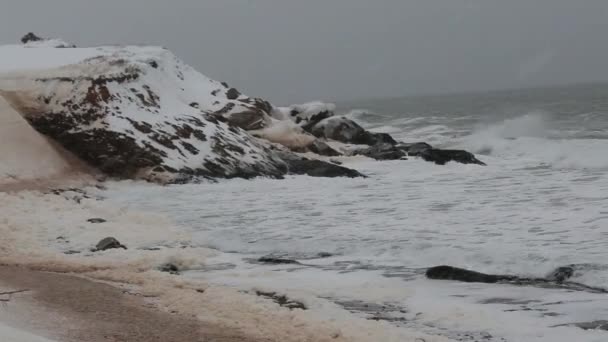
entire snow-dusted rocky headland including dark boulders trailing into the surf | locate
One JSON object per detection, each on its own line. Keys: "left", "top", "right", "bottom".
{"left": 0, "top": 34, "right": 483, "bottom": 183}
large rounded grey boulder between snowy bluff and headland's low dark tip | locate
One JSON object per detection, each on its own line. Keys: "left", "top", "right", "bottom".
{"left": 309, "top": 117, "right": 397, "bottom": 146}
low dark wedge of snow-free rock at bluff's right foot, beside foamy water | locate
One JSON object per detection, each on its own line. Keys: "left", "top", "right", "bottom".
{"left": 282, "top": 154, "right": 365, "bottom": 178}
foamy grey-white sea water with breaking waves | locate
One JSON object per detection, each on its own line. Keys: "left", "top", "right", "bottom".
{"left": 103, "top": 85, "right": 608, "bottom": 341}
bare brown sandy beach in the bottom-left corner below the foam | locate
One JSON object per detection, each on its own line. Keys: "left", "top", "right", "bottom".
{"left": 0, "top": 266, "right": 262, "bottom": 342}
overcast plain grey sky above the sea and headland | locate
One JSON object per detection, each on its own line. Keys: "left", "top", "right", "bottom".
{"left": 0, "top": 0, "right": 608, "bottom": 104}
